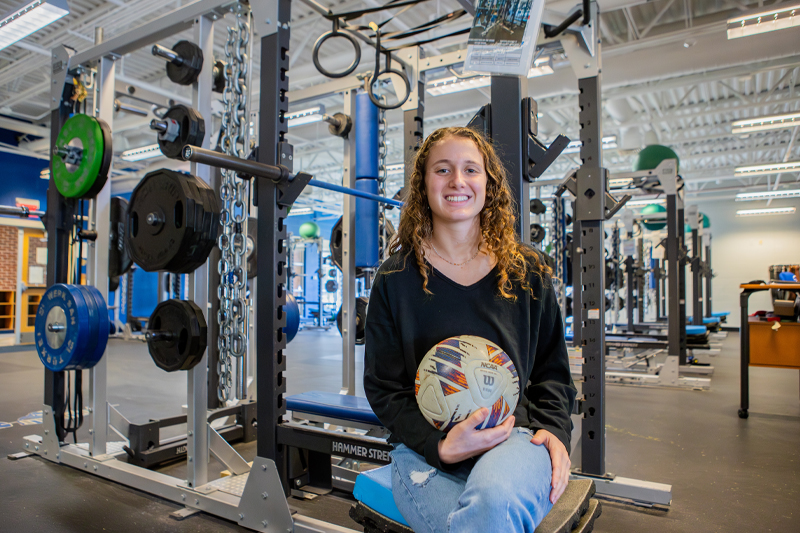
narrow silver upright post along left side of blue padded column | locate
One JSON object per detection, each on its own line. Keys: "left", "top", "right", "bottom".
{"left": 340, "top": 90, "right": 358, "bottom": 396}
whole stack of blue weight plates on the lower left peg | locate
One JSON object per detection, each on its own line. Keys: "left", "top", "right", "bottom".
{"left": 34, "top": 283, "right": 109, "bottom": 372}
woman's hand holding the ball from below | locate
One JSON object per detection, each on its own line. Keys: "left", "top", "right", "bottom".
{"left": 439, "top": 407, "right": 514, "bottom": 464}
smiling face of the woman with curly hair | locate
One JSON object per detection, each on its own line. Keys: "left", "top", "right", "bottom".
{"left": 425, "top": 136, "right": 487, "bottom": 228}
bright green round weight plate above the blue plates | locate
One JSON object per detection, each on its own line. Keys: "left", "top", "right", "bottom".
{"left": 50, "top": 115, "right": 111, "bottom": 198}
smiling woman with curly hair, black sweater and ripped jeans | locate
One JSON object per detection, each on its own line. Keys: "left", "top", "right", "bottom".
{"left": 364, "top": 128, "right": 576, "bottom": 533}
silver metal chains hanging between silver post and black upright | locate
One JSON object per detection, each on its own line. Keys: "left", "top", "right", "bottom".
{"left": 217, "top": 10, "right": 250, "bottom": 402}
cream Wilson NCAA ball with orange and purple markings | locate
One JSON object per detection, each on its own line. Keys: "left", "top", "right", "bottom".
{"left": 414, "top": 335, "right": 519, "bottom": 431}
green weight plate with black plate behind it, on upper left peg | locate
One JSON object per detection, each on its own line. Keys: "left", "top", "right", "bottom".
{"left": 51, "top": 115, "right": 112, "bottom": 198}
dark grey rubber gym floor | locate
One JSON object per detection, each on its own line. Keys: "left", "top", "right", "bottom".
{"left": 0, "top": 329, "right": 800, "bottom": 533}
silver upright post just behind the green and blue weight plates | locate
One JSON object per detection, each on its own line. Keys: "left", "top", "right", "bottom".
{"left": 87, "top": 37, "right": 116, "bottom": 457}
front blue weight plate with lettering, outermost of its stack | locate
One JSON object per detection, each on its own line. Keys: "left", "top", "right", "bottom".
{"left": 34, "top": 283, "right": 89, "bottom": 372}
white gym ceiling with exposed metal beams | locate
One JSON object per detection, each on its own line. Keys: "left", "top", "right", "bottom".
{"left": 0, "top": 0, "right": 800, "bottom": 209}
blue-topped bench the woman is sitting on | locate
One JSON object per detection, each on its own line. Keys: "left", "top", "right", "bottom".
{"left": 350, "top": 465, "right": 602, "bottom": 533}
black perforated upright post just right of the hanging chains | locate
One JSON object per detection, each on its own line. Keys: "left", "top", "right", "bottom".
{"left": 254, "top": 0, "right": 292, "bottom": 494}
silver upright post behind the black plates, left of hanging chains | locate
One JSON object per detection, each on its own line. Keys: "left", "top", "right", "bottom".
{"left": 186, "top": 12, "right": 216, "bottom": 487}
